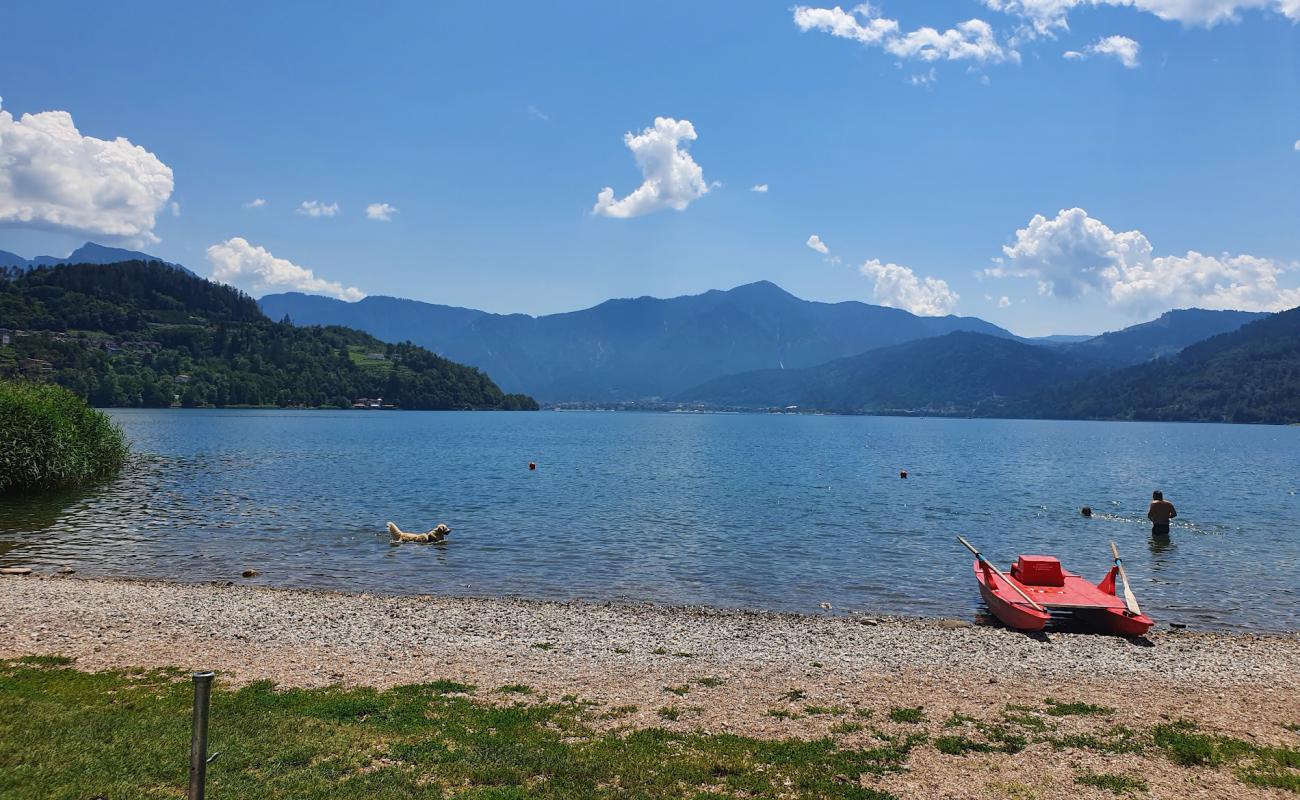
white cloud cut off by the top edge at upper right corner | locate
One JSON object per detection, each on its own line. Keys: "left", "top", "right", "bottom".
{"left": 984, "top": 0, "right": 1300, "bottom": 35}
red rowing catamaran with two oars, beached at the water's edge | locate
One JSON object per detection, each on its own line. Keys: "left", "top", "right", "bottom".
{"left": 958, "top": 536, "right": 1156, "bottom": 636}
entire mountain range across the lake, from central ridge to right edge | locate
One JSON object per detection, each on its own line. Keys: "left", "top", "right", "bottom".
{"left": 0, "top": 245, "right": 1300, "bottom": 421}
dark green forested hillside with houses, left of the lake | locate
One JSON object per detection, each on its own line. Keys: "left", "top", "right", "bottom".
{"left": 0, "top": 261, "right": 537, "bottom": 410}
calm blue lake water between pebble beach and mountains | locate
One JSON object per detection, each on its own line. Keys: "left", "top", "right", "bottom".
{"left": 0, "top": 411, "right": 1300, "bottom": 631}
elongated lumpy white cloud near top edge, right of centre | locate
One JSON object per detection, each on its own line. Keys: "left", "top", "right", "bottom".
{"left": 793, "top": 4, "right": 1021, "bottom": 64}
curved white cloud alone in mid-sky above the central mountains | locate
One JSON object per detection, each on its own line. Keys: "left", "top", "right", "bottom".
{"left": 592, "top": 117, "right": 710, "bottom": 219}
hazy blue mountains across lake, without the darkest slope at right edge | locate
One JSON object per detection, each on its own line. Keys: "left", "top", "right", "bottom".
{"left": 260, "top": 281, "right": 1266, "bottom": 410}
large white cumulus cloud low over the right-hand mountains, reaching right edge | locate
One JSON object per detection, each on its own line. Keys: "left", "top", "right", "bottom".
{"left": 985, "top": 208, "right": 1300, "bottom": 313}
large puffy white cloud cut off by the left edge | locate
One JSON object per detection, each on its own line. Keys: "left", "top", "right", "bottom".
{"left": 0, "top": 99, "right": 174, "bottom": 243}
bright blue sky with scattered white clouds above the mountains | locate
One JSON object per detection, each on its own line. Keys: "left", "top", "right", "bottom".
{"left": 0, "top": 0, "right": 1300, "bottom": 334}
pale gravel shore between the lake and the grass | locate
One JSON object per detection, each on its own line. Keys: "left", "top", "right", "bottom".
{"left": 0, "top": 576, "right": 1300, "bottom": 797}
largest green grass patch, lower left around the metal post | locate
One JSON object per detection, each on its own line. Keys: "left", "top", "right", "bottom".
{"left": 0, "top": 661, "right": 923, "bottom": 800}
